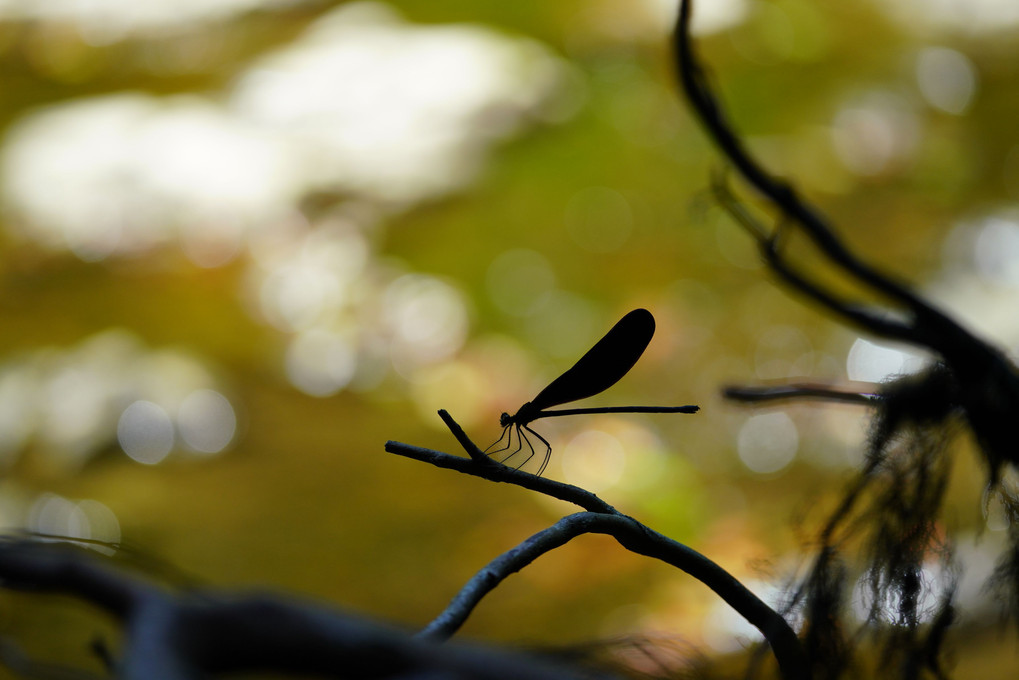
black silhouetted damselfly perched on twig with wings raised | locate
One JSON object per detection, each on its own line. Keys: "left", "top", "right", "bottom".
{"left": 485, "top": 309, "right": 700, "bottom": 477}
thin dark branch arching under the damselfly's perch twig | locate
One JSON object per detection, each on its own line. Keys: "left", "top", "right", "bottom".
{"left": 419, "top": 513, "right": 809, "bottom": 679}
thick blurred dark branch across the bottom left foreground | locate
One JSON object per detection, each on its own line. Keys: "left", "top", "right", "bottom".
{"left": 0, "top": 539, "right": 619, "bottom": 680}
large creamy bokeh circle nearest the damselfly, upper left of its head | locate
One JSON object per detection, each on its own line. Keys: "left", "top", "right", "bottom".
{"left": 383, "top": 274, "right": 467, "bottom": 375}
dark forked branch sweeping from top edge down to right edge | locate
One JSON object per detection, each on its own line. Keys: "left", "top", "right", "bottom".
{"left": 675, "top": 0, "right": 1019, "bottom": 482}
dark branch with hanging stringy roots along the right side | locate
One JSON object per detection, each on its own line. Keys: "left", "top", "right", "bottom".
{"left": 675, "top": 0, "right": 1019, "bottom": 679}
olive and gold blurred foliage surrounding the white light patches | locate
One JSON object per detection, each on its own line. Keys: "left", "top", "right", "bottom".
{"left": 0, "top": 0, "right": 1019, "bottom": 676}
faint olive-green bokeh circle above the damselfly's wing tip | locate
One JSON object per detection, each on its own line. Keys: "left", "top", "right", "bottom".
{"left": 566, "top": 187, "right": 634, "bottom": 253}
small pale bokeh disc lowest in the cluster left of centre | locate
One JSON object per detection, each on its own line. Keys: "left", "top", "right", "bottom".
{"left": 286, "top": 328, "right": 358, "bottom": 397}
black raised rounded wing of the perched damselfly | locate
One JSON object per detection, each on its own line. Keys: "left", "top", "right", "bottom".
{"left": 531, "top": 309, "right": 654, "bottom": 411}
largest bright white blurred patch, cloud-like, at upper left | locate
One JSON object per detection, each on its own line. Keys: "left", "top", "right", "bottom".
{"left": 0, "top": 0, "right": 569, "bottom": 260}
